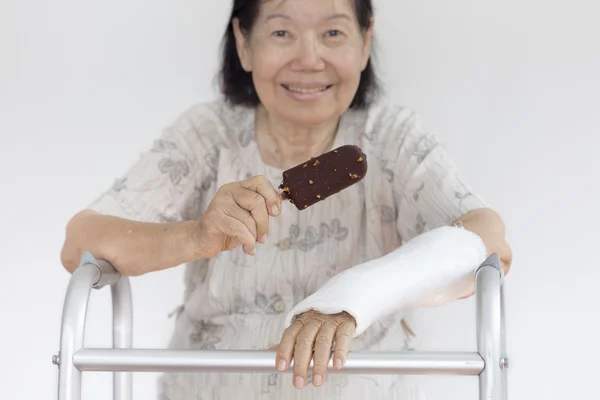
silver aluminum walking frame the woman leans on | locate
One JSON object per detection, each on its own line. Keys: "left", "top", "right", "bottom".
{"left": 52, "top": 253, "right": 508, "bottom": 400}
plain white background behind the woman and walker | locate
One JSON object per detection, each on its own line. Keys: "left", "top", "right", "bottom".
{"left": 0, "top": 0, "right": 600, "bottom": 400}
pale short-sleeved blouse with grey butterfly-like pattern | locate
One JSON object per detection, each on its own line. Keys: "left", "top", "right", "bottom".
{"left": 90, "top": 100, "right": 487, "bottom": 400}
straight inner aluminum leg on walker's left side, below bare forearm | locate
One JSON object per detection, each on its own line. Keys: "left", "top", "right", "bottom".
{"left": 111, "top": 276, "right": 133, "bottom": 400}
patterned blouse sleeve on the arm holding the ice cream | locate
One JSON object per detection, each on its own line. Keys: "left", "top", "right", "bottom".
{"left": 88, "top": 104, "right": 218, "bottom": 222}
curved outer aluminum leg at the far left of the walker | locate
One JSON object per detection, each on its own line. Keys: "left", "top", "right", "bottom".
{"left": 57, "top": 264, "right": 100, "bottom": 400}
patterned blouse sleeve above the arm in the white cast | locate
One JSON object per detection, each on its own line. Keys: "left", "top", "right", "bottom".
{"left": 385, "top": 111, "right": 489, "bottom": 240}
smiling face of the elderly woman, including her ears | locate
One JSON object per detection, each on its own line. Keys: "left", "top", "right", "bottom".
{"left": 234, "top": 0, "right": 372, "bottom": 126}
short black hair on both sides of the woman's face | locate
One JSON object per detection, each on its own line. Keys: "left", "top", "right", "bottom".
{"left": 219, "top": 0, "right": 379, "bottom": 108}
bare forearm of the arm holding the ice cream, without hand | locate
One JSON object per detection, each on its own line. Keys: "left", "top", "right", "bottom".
{"left": 61, "top": 210, "right": 201, "bottom": 276}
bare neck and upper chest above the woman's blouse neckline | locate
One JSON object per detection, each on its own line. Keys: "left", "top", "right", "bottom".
{"left": 255, "top": 106, "right": 339, "bottom": 169}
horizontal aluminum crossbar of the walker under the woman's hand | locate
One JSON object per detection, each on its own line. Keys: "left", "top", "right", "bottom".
{"left": 73, "top": 349, "right": 484, "bottom": 375}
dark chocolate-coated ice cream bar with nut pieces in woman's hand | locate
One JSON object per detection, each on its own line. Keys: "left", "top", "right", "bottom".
{"left": 279, "top": 145, "right": 367, "bottom": 210}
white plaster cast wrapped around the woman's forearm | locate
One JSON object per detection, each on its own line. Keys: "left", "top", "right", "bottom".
{"left": 285, "top": 227, "right": 487, "bottom": 337}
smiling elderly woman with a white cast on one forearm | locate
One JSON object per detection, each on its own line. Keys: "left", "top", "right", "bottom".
{"left": 62, "top": 0, "right": 511, "bottom": 400}
